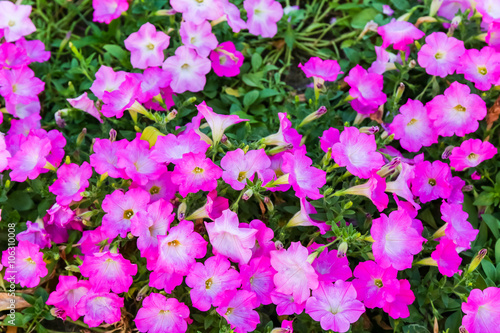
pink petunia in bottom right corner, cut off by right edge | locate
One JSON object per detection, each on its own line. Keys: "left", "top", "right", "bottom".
{"left": 462, "top": 287, "right": 500, "bottom": 333}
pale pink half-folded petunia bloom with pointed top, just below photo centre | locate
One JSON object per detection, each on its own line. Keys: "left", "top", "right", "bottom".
{"left": 205, "top": 209, "right": 257, "bottom": 264}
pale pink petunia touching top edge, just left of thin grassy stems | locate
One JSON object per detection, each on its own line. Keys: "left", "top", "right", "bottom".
{"left": 243, "top": 0, "right": 283, "bottom": 38}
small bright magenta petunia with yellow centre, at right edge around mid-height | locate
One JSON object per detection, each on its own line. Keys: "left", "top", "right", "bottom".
{"left": 450, "top": 139, "right": 498, "bottom": 171}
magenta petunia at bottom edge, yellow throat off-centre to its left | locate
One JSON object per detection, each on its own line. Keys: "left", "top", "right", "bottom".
{"left": 217, "top": 290, "right": 260, "bottom": 333}
